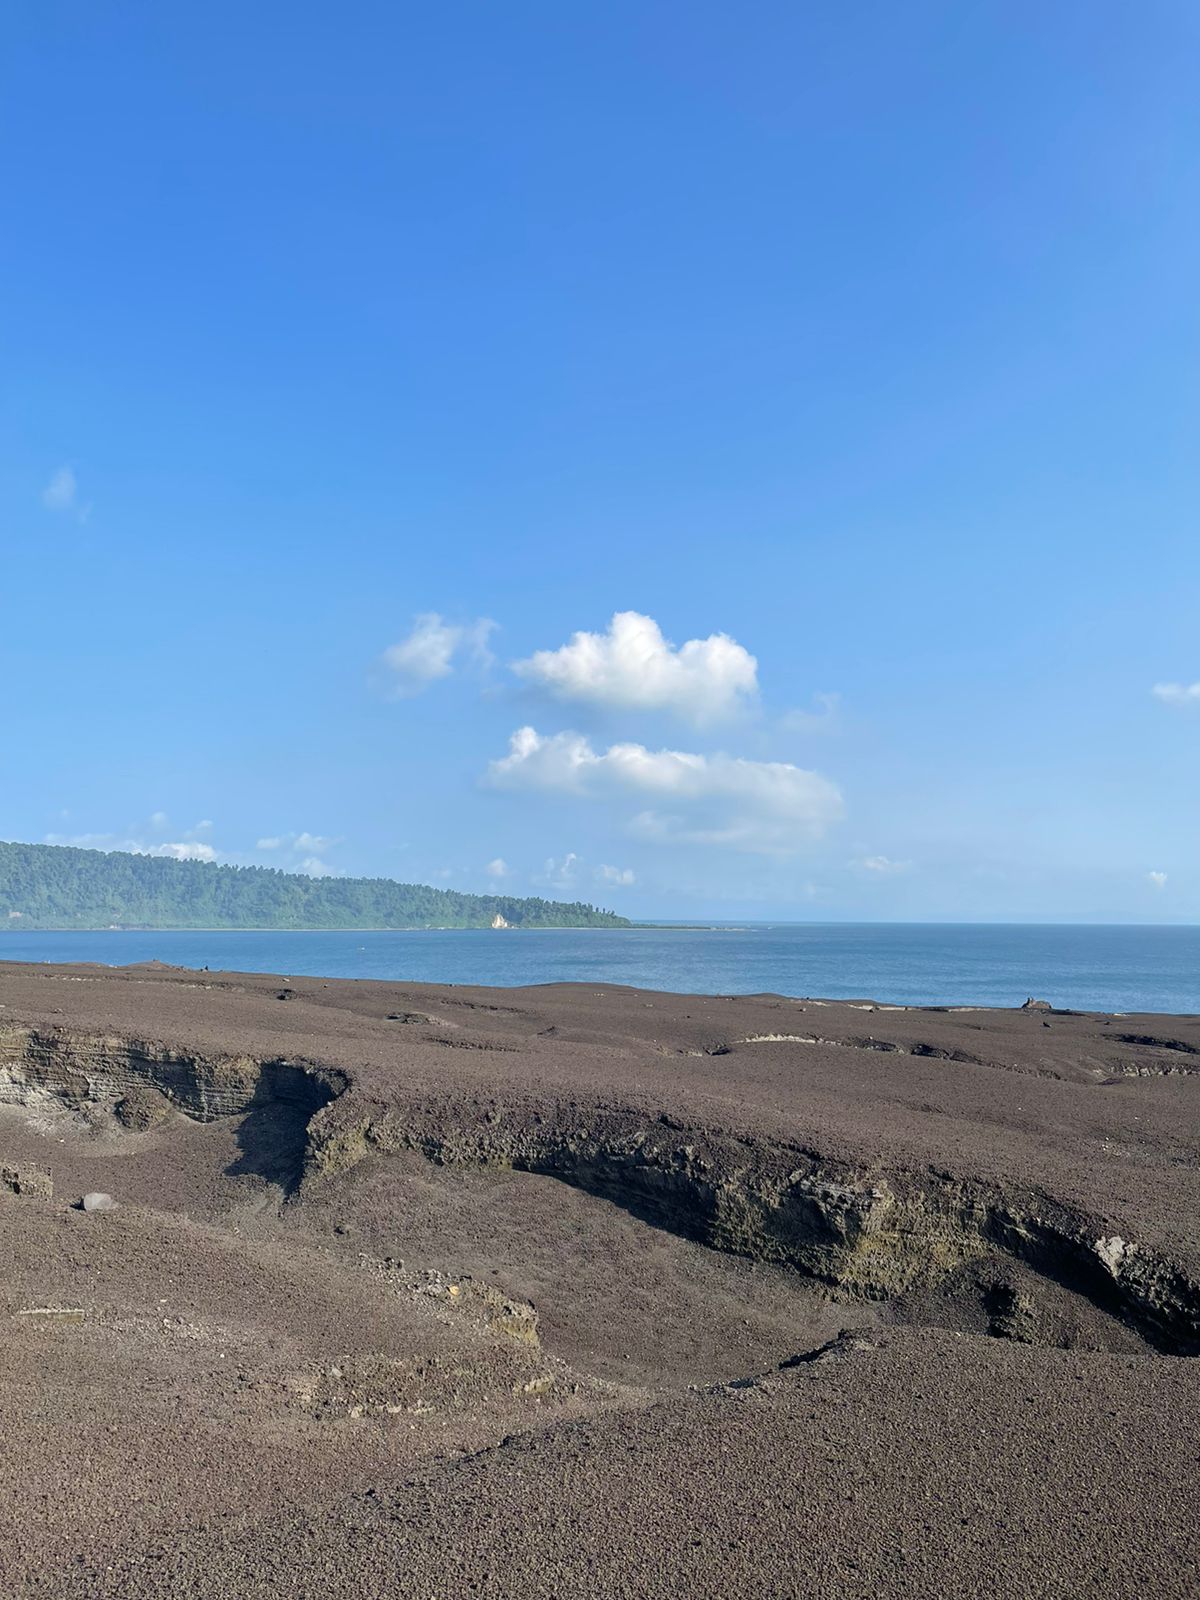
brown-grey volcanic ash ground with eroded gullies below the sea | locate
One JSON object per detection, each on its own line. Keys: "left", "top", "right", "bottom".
{"left": 0, "top": 965, "right": 1200, "bottom": 1600}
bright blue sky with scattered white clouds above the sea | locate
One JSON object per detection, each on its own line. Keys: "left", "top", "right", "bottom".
{"left": 0, "top": 0, "right": 1200, "bottom": 922}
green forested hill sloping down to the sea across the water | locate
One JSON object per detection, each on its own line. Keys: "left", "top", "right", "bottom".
{"left": 0, "top": 843, "right": 629, "bottom": 950}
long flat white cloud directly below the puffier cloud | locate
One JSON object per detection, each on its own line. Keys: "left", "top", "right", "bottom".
{"left": 488, "top": 728, "right": 843, "bottom": 854}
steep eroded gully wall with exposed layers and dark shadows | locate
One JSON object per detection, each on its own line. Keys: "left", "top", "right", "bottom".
{"left": 0, "top": 1029, "right": 1200, "bottom": 1355}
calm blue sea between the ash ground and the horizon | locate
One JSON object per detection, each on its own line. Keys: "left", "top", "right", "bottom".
{"left": 0, "top": 923, "right": 1200, "bottom": 1011}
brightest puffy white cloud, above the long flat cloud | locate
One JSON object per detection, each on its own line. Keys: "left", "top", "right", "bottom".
{"left": 514, "top": 611, "right": 758, "bottom": 723}
